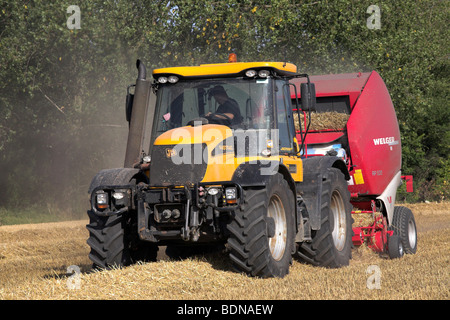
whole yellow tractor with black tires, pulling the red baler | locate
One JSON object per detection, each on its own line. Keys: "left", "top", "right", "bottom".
{"left": 87, "top": 56, "right": 352, "bottom": 277}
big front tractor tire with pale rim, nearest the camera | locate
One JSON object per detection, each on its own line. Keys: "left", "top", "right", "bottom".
{"left": 227, "top": 173, "right": 295, "bottom": 278}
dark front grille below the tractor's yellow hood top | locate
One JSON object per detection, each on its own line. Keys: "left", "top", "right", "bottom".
{"left": 150, "top": 143, "right": 208, "bottom": 187}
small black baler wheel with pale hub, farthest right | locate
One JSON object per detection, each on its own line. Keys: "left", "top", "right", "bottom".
{"left": 388, "top": 206, "right": 417, "bottom": 254}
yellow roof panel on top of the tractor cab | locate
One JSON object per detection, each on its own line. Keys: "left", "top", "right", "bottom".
{"left": 153, "top": 62, "right": 297, "bottom": 77}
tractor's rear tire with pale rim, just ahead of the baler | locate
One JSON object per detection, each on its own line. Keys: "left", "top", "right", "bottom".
{"left": 297, "top": 168, "right": 353, "bottom": 268}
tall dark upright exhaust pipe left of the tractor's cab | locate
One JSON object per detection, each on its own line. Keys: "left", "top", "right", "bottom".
{"left": 124, "top": 60, "right": 152, "bottom": 168}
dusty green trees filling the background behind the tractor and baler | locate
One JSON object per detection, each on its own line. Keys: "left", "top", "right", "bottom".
{"left": 0, "top": 0, "right": 450, "bottom": 210}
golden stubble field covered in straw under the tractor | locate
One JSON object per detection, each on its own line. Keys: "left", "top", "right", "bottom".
{"left": 0, "top": 203, "right": 450, "bottom": 300}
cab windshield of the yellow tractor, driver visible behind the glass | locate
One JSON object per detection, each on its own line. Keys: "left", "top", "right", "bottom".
{"left": 152, "top": 78, "right": 273, "bottom": 137}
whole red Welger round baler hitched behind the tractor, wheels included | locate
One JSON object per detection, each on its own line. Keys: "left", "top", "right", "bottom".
{"left": 291, "top": 71, "right": 417, "bottom": 257}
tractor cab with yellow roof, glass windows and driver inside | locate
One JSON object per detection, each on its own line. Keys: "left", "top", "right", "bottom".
{"left": 150, "top": 60, "right": 311, "bottom": 156}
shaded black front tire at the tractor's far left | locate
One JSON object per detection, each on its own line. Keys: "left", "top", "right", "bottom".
{"left": 86, "top": 211, "right": 158, "bottom": 269}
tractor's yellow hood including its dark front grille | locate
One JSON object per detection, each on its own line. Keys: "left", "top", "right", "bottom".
{"left": 150, "top": 124, "right": 237, "bottom": 186}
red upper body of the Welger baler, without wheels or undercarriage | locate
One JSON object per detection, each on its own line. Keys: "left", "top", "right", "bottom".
{"left": 292, "top": 71, "right": 401, "bottom": 202}
